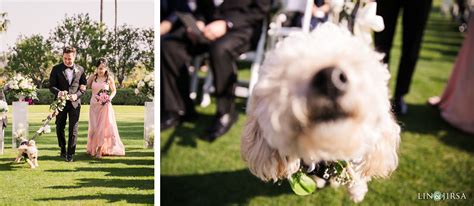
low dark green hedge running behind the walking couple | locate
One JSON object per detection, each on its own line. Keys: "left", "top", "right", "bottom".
{"left": 5, "top": 89, "right": 151, "bottom": 105}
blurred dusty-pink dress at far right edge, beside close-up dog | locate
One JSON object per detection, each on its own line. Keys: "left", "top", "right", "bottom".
{"left": 439, "top": 18, "right": 474, "bottom": 134}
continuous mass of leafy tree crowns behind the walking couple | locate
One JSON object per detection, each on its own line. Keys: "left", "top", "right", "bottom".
{"left": 47, "top": 14, "right": 154, "bottom": 87}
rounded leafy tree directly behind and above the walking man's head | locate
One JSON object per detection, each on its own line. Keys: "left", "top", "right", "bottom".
{"left": 51, "top": 14, "right": 111, "bottom": 73}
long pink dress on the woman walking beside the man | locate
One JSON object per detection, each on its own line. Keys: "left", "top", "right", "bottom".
{"left": 87, "top": 81, "right": 125, "bottom": 156}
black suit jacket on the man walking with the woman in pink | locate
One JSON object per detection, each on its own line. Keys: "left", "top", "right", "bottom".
{"left": 49, "top": 63, "right": 87, "bottom": 108}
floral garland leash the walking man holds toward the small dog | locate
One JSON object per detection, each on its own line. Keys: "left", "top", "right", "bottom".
{"left": 31, "top": 91, "right": 69, "bottom": 140}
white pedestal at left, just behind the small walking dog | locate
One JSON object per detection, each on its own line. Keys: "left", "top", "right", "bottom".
{"left": 12, "top": 102, "right": 28, "bottom": 149}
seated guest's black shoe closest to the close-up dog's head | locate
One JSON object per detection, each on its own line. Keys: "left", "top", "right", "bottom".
{"left": 202, "top": 112, "right": 239, "bottom": 142}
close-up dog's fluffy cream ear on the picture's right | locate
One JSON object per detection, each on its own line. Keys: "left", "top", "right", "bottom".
{"left": 364, "top": 115, "right": 400, "bottom": 178}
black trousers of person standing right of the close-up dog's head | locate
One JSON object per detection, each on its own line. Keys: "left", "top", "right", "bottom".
{"left": 374, "top": 0, "right": 432, "bottom": 97}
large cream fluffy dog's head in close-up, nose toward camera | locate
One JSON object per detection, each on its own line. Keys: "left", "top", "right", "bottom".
{"left": 241, "top": 23, "right": 400, "bottom": 202}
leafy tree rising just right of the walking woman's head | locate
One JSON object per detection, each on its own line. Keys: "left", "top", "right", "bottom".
{"left": 107, "top": 25, "right": 142, "bottom": 87}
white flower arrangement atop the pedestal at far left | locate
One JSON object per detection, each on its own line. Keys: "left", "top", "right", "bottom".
{"left": 5, "top": 74, "right": 38, "bottom": 103}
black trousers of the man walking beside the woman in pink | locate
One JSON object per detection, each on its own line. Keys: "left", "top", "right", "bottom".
{"left": 56, "top": 101, "right": 81, "bottom": 155}
